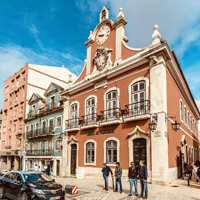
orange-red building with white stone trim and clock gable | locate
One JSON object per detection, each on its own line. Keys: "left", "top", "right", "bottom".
{"left": 61, "top": 7, "right": 200, "bottom": 184}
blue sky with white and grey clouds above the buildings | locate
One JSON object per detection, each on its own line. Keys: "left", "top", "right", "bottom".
{"left": 0, "top": 0, "right": 200, "bottom": 113}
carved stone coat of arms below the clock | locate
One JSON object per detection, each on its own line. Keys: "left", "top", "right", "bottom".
{"left": 93, "top": 47, "right": 109, "bottom": 71}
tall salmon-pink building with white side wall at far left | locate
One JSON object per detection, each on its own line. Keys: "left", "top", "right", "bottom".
{"left": 0, "top": 63, "right": 75, "bottom": 171}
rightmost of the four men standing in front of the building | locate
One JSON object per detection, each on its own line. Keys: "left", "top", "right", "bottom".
{"left": 138, "top": 160, "right": 148, "bottom": 199}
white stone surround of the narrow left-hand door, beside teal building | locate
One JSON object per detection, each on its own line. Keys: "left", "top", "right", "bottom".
{"left": 68, "top": 135, "right": 79, "bottom": 175}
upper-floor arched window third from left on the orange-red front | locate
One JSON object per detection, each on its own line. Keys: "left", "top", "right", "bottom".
{"left": 106, "top": 90, "right": 118, "bottom": 120}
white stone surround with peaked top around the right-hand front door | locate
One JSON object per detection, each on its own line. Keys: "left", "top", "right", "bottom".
{"left": 128, "top": 126, "right": 151, "bottom": 176}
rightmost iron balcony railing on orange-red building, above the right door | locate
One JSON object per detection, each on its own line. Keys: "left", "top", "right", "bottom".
{"left": 124, "top": 100, "right": 150, "bottom": 118}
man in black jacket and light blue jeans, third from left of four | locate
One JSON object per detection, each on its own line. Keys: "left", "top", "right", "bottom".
{"left": 128, "top": 162, "right": 138, "bottom": 196}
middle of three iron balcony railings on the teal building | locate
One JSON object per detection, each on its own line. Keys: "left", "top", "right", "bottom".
{"left": 26, "top": 126, "right": 54, "bottom": 139}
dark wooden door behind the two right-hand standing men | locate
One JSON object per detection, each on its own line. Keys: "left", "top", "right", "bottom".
{"left": 133, "top": 138, "right": 147, "bottom": 168}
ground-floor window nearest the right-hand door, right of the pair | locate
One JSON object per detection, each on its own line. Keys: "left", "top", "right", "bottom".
{"left": 106, "top": 140, "right": 117, "bottom": 163}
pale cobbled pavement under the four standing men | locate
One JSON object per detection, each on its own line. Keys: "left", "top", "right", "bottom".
{"left": 55, "top": 178, "right": 200, "bottom": 200}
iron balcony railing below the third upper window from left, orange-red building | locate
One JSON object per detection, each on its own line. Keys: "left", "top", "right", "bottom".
{"left": 97, "top": 107, "right": 120, "bottom": 122}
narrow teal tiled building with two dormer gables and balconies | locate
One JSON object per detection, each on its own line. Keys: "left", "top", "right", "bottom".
{"left": 24, "top": 83, "right": 64, "bottom": 176}
